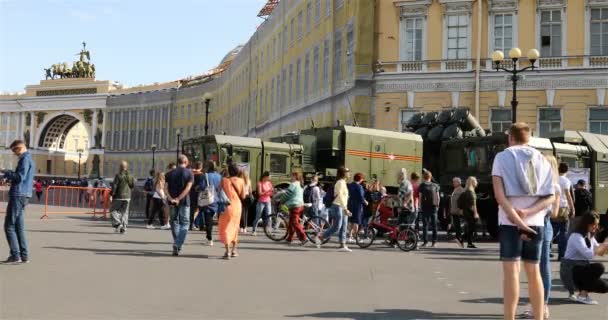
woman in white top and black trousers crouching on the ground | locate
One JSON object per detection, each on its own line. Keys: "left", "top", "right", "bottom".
{"left": 560, "top": 213, "right": 608, "bottom": 304}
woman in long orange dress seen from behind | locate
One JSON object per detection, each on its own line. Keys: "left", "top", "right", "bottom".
{"left": 218, "top": 164, "right": 245, "bottom": 260}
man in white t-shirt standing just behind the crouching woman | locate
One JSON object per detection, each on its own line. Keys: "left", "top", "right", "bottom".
{"left": 551, "top": 162, "right": 574, "bottom": 260}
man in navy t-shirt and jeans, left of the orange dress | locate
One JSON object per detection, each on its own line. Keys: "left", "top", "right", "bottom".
{"left": 165, "top": 154, "right": 194, "bottom": 256}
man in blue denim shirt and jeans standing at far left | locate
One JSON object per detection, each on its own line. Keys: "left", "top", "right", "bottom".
{"left": 4, "top": 140, "right": 36, "bottom": 263}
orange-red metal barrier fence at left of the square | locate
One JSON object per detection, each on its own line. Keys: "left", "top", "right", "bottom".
{"left": 40, "top": 186, "right": 110, "bottom": 219}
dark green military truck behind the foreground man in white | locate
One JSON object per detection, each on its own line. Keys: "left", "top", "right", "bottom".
{"left": 438, "top": 131, "right": 608, "bottom": 236}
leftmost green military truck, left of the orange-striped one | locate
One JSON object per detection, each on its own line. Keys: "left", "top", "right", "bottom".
{"left": 182, "top": 135, "right": 302, "bottom": 186}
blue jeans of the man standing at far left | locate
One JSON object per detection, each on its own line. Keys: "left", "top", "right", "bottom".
{"left": 4, "top": 196, "right": 30, "bottom": 259}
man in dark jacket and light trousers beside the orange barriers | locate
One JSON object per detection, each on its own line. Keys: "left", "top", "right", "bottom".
{"left": 110, "top": 161, "right": 134, "bottom": 233}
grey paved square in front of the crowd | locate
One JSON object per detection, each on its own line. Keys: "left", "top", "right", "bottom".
{"left": 0, "top": 205, "right": 608, "bottom": 320}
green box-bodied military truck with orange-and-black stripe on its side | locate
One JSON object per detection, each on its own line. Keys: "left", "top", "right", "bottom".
{"left": 271, "top": 125, "right": 422, "bottom": 192}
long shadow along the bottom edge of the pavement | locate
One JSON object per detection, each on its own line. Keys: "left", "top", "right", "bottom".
{"left": 286, "top": 309, "right": 503, "bottom": 320}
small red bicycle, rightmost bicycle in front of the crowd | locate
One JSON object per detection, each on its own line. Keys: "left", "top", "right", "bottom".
{"left": 355, "top": 196, "right": 418, "bottom": 252}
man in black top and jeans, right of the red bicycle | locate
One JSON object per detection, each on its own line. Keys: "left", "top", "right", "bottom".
{"left": 419, "top": 170, "right": 440, "bottom": 248}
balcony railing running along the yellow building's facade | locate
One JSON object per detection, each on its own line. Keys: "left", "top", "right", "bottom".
{"left": 375, "top": 55, "right": 608, "bottom": 73}
